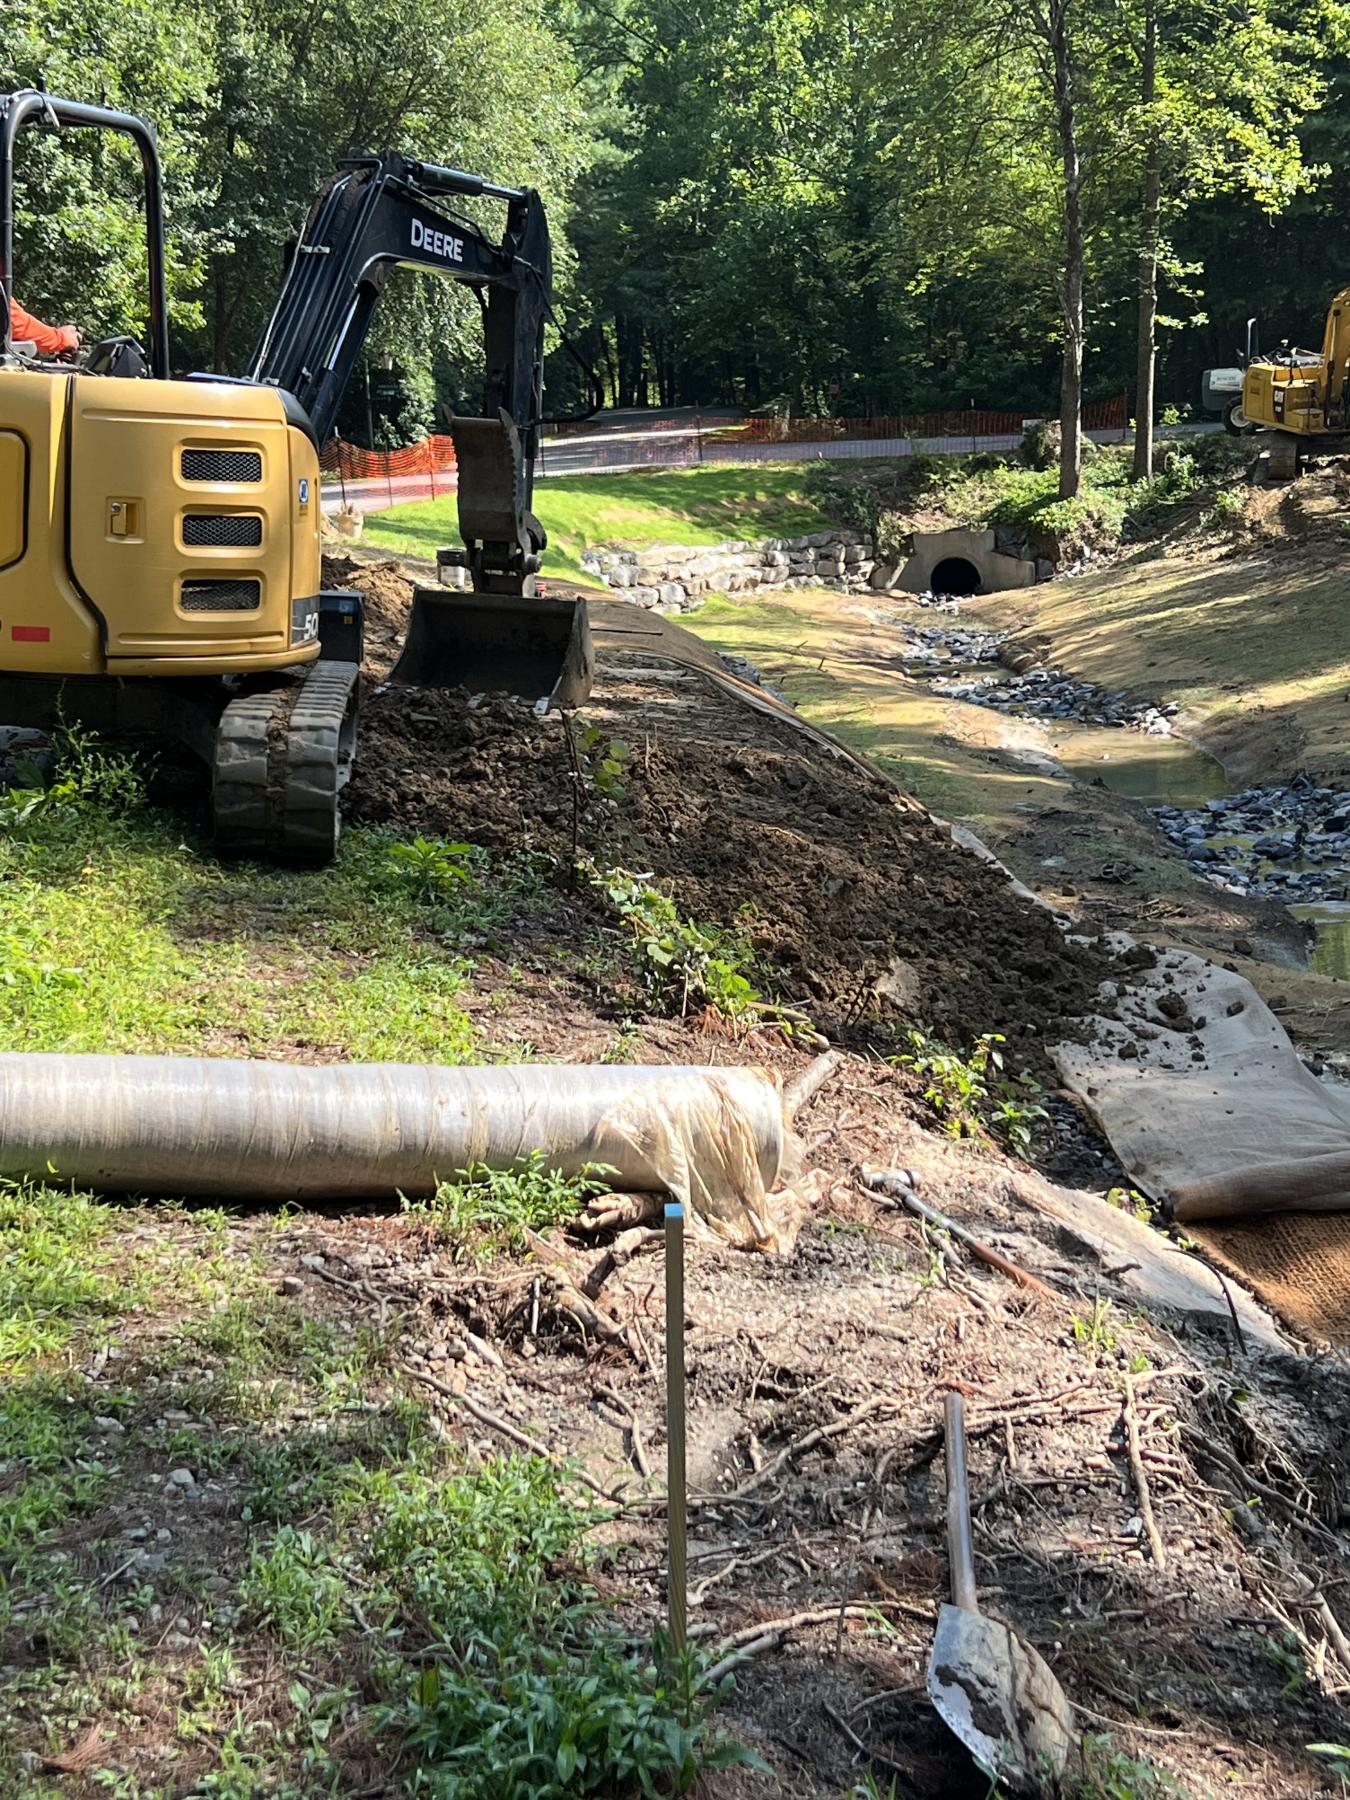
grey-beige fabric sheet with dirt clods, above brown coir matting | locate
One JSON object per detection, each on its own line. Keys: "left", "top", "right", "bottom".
{"left": 1053, "top": 950, "right": 1350, "bottom": 1219}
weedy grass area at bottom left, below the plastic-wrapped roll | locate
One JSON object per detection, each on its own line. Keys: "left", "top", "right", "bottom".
{"left": 0, "top": 1186, "right": 734, "bottom": 1800}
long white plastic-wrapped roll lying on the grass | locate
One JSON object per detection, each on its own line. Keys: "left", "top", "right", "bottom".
{"left": 0, "top": 1055, "right": 787, "bottom": 1249}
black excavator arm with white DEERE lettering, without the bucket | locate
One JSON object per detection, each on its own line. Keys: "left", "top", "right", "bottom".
{"left": 248, "top": 151, "right": 551, "bottom": 594}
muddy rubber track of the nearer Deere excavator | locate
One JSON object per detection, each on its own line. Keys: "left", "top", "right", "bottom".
{"left": 212, "top": 661, "right": 356, "bottom": 864}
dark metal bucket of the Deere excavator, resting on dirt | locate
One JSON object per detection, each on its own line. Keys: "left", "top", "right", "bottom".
{"left": 389, "top": 587, "right": 596, "bottom": 707}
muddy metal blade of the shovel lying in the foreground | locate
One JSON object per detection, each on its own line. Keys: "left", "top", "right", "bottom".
{"left": 929, "top": 1606, "right": 1076, "bottom": 1795}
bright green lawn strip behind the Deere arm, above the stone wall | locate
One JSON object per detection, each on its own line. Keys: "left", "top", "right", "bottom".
{"left": 364, "top": 463, "right": 828, "bottom": 580}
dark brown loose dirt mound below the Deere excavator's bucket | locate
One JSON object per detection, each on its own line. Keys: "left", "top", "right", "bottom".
{"left": 346, "top": 554, "right": 1105, "bottom": 1060}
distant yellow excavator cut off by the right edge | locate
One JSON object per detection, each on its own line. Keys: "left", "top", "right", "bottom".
{"left": 1233, "top": 288, "right": 1350, "bottom": 481}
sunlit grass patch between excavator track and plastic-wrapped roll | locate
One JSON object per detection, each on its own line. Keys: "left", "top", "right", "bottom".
{"left": 0, "top": 812, "right": 509, "bottom": 1062}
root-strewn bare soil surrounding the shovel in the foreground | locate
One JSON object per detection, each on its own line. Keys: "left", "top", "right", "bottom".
{"left": 248, "top": 1060, "right": 1350, "bottom": 1800}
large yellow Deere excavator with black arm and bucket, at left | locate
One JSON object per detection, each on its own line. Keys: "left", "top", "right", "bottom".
{"left": 0, "top": 90, "right": 592, "bottom": 862}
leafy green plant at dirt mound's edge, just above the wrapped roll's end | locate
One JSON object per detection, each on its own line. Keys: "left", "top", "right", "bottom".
{"left": 590, "top": 868, "right": 774, "bottom": 1019}
